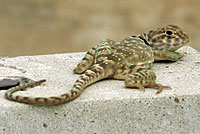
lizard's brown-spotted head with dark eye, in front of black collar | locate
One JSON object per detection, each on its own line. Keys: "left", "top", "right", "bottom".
{"left": 145, "top": 25, "right": 189, "bottom": 51}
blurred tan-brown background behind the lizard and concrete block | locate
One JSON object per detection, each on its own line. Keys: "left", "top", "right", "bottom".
{"left": 0, "top": 0, "right": 200, "bottom": 57}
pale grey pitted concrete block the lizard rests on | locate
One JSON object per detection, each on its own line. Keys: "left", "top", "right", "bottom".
{"left": 0, "top": 46, "right": 200, "bottom": 134}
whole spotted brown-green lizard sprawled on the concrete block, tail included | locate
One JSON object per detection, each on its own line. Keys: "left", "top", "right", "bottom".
{"left": 5, "top": 25, "right": 189, "bottom": 105}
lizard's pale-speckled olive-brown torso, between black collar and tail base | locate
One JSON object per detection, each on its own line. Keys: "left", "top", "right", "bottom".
{"left": 95, "top": 36, "right": 154, "bottom": 79}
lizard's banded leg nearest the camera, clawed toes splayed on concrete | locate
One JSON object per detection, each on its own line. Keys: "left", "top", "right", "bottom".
{"left": 125, "top": 70, "right": 170, "bottom": 94}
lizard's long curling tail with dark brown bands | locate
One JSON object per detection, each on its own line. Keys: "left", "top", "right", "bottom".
{"left": 5, "top": 61, "right": 114, "bottom": 105}
